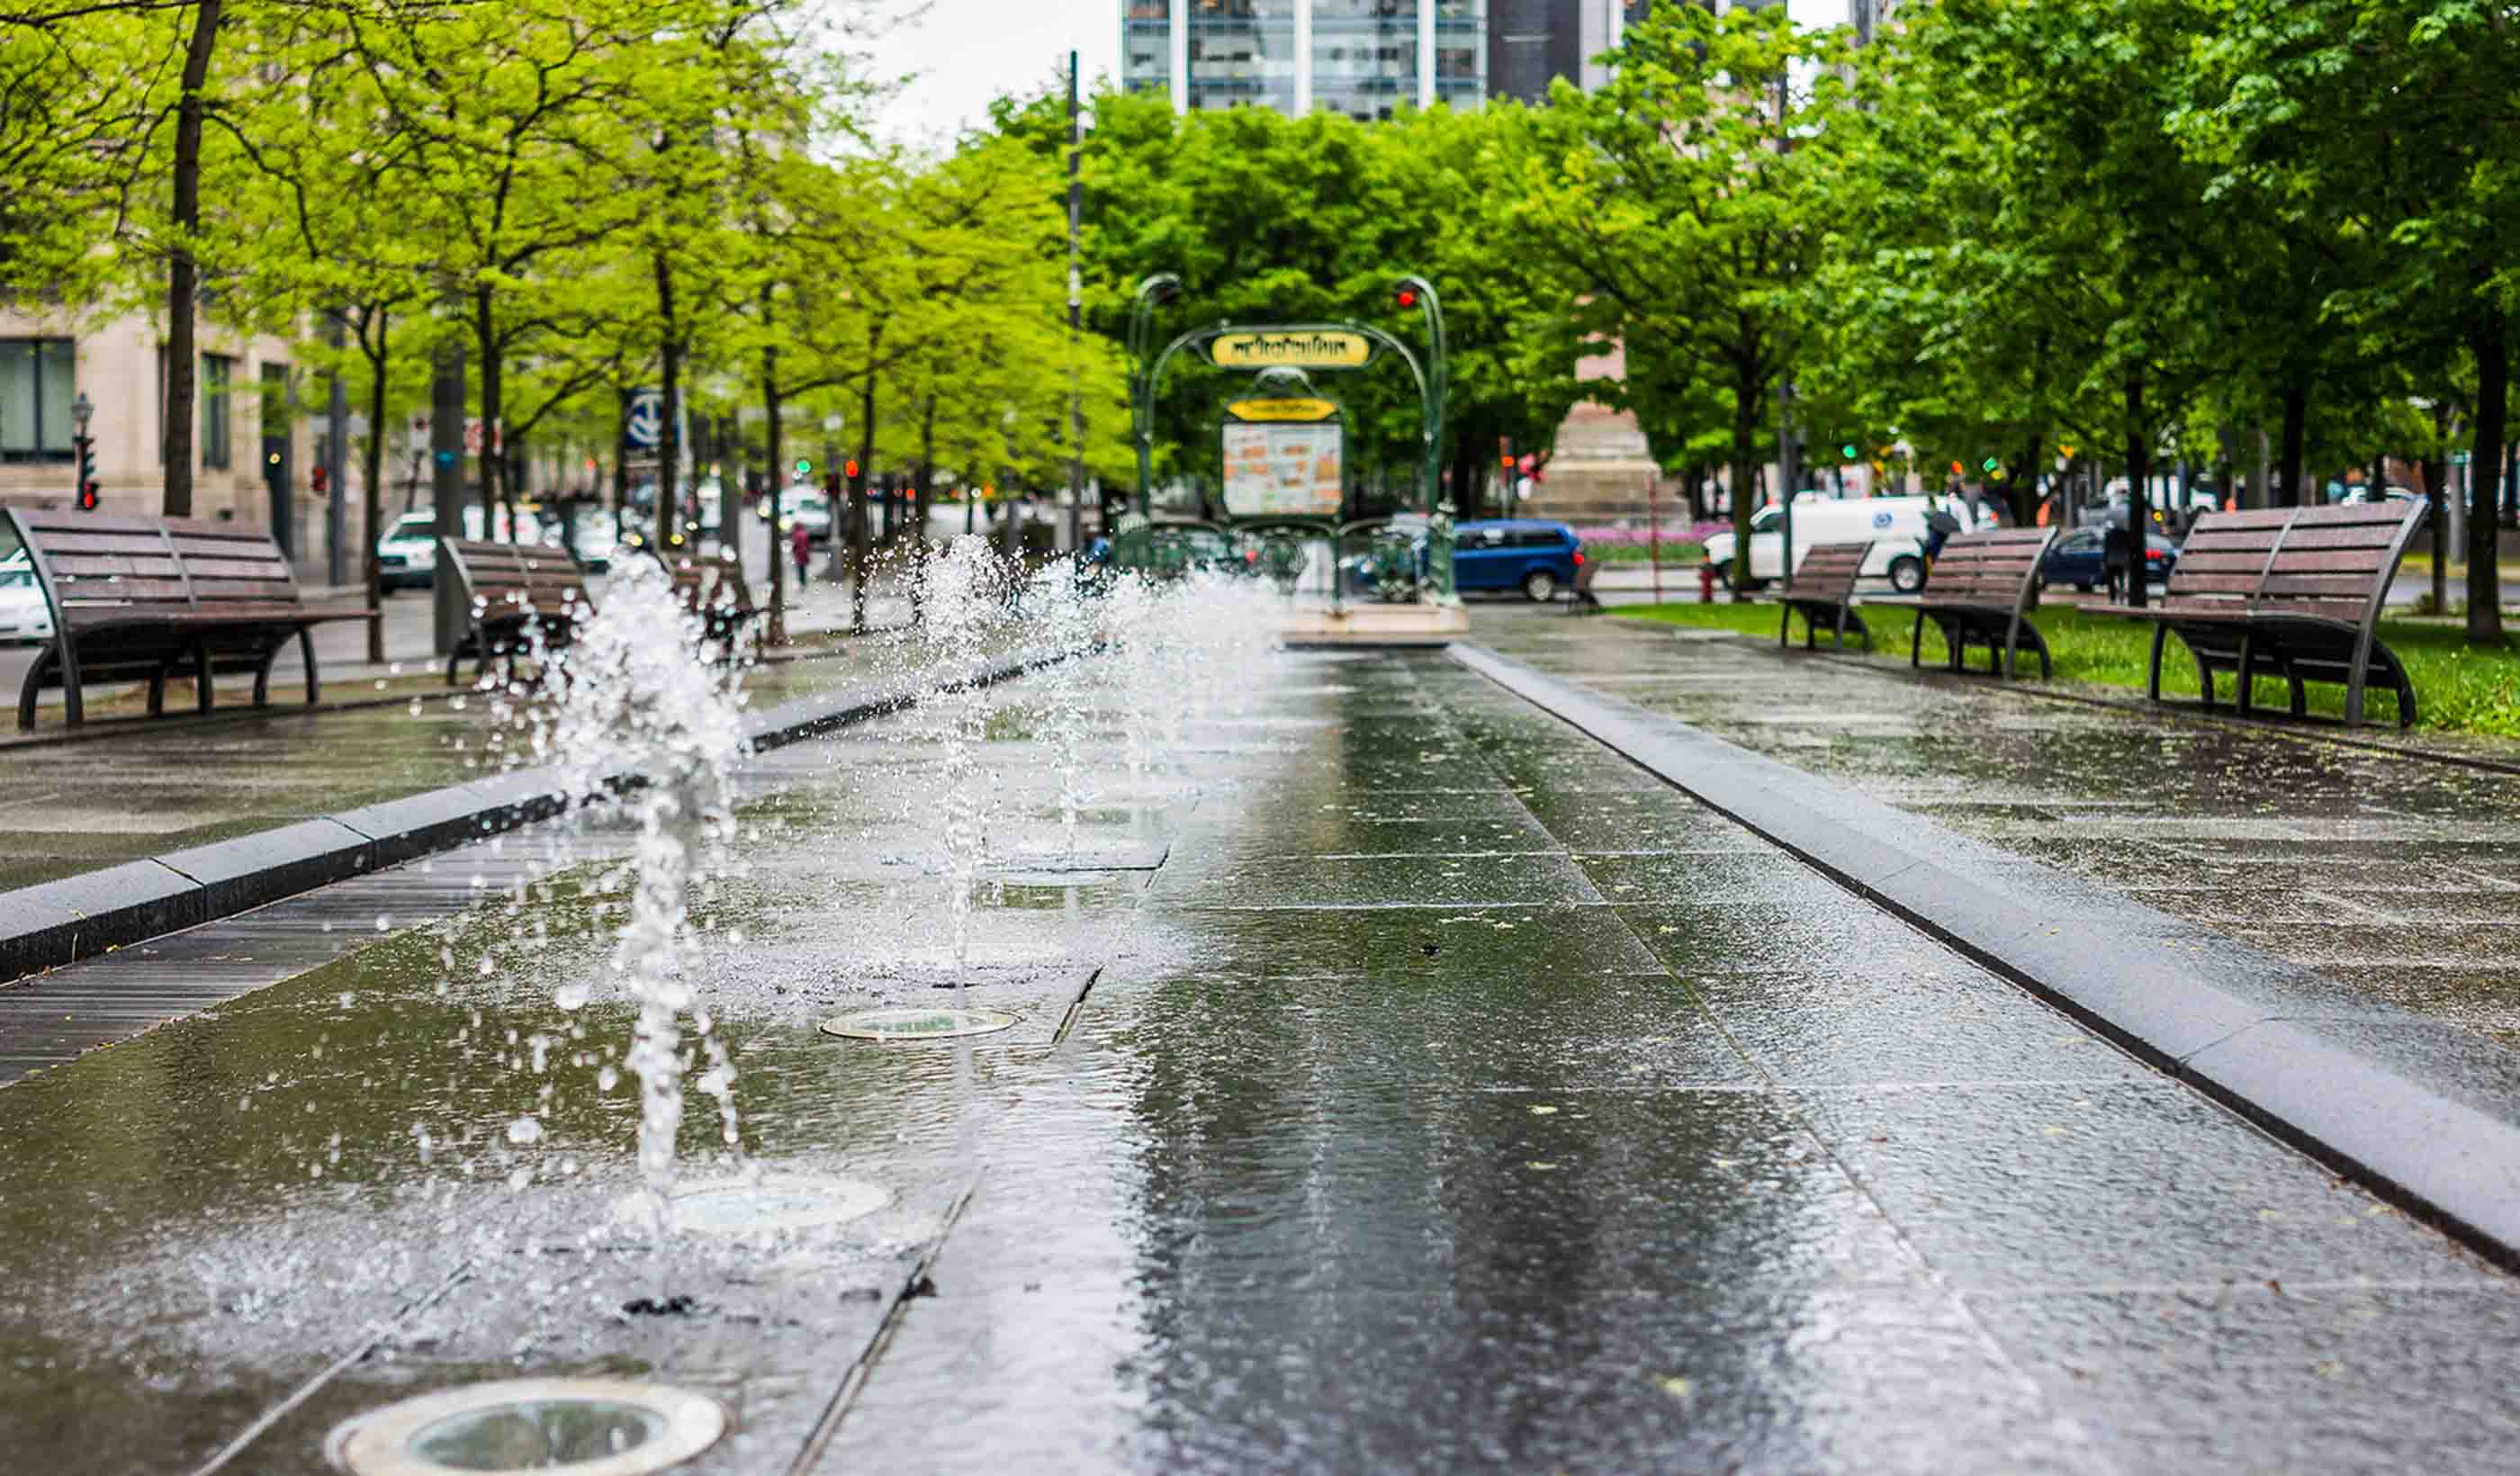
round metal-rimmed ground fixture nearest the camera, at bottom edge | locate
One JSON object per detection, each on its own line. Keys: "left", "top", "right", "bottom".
{"left": 325, "top": 1378, "right": 725, "bottom": 1476}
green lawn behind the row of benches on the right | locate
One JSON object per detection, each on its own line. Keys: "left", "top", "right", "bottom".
{"left": 1618, "top": 605, "right": 2520, "bottom": 738}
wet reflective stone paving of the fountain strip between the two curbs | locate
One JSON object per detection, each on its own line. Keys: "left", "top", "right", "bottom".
{"left": 0, "top": 637, "right": 2520, "bottom": 1473}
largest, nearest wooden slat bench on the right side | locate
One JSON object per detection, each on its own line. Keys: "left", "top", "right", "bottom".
{"left": 2102, "top": 501, "right": 2426, "bottom": 728}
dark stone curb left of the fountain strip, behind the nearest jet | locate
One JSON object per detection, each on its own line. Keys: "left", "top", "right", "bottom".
{"left": 0, "top": 655, "right": 1056, "bottom": 982}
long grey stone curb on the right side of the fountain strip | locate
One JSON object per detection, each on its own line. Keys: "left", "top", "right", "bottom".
{"left": 1446, "top": 644, "right": 2520, "bottom": 1267}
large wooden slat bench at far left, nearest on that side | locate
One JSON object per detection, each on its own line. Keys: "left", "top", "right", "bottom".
{"left": 0, "top": 507, "right": 378, "bottom": 728}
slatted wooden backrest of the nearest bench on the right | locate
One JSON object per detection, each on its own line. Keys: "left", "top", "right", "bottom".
{"left": 2162, "top": 501, "right": 2426, "bottom": 625}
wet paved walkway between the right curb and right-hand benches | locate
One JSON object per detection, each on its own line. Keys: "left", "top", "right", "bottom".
{"left": 1472, "top": 609, "right": 2520, "bottom": 1108}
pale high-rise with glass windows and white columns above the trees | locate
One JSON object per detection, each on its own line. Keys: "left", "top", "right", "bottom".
{"left": 1121, "top": 0, "right": 1490, "bottom": 119}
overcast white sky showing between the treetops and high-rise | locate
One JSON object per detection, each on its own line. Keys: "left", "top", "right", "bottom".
{"left": 875, "top": 0, "right": 1847, "bottom": 144}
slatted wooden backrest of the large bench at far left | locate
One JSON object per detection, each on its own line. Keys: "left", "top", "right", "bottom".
{"left": 0, "top": 507, "right": 300, "bottom": 615}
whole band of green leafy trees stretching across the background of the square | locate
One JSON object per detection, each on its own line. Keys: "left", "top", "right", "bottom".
{"left": 0, "top": 0, "right": 2520, "bottom": 640}
